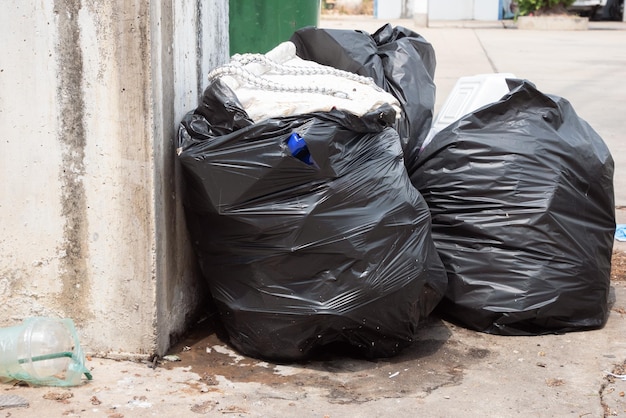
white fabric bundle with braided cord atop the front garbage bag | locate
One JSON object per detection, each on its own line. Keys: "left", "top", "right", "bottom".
{"left": 209, "top": 42, "right": 400, "bottom": 122}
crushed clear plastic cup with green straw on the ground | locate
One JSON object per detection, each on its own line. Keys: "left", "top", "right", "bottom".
{"left": 0, "top": 317, "right": 91, "bottom": 386}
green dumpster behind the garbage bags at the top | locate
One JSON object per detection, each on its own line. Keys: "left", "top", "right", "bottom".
{"left": 228, "top": 0, "right": 321, "bottom": 55}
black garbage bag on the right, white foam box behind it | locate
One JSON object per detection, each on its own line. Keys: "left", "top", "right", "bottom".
{"left": 411, "top": 80, "right": 615, "bottom": 335}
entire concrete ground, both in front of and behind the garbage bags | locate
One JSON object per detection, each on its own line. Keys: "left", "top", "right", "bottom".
{"left": 0, "top": 17, "right": 626, "bottom": 418}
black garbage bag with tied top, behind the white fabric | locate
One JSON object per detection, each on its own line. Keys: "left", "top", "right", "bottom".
{"left": 290, "top": 24, "right": 436, "bottom": 174}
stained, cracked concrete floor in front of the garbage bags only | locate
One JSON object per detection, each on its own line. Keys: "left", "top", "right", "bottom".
{"left": 0, "top": 252, "right": 626, "bottom": 418}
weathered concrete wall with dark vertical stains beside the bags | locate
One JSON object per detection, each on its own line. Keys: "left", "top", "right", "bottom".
{"left": 0, "top": 0, "right": 228, "bottom": 356}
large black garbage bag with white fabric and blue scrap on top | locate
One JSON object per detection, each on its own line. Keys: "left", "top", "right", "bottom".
{"left": 178, "top": 80, "right": 447, "bottom": 360}
